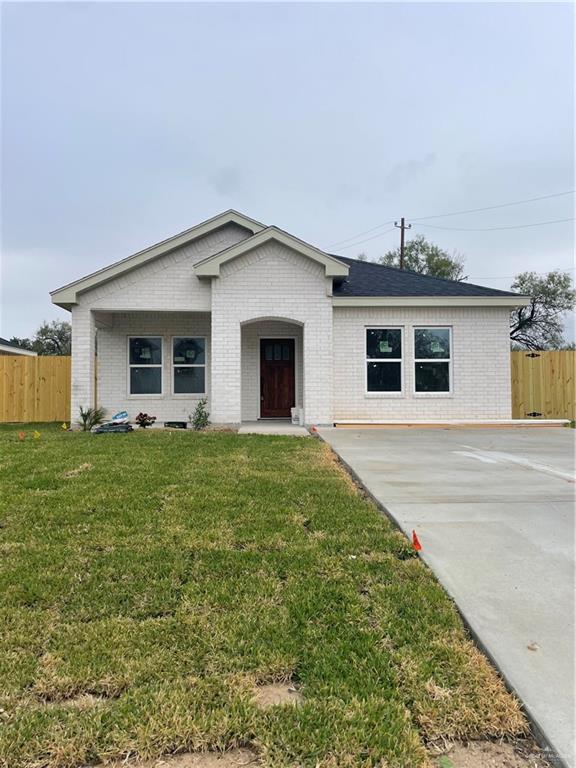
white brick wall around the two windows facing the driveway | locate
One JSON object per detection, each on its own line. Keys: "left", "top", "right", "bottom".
{"left": 334, "top": 307, "right": 511, "bottom": 421}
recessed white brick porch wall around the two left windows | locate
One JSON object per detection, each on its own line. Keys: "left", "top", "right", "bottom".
{"left": 98, "top": 312, "right": 210, "bottom": 422}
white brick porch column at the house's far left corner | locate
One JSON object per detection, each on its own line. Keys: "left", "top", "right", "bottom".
{"left": 70, "top": 304, "right": 96, "bottom": 424}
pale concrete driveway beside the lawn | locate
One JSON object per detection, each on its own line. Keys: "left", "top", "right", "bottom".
{"left": 319, "top": 428, "right": 576, "bottom": 766}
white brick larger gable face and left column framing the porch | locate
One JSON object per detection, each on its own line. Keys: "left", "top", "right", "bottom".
{"left": 71, "top": 224, "right": 250, "bottom": 421}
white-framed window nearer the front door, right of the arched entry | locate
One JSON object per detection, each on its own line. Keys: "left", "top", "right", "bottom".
{"left": 366, "top": 328, "right": 402, "bottom": 392}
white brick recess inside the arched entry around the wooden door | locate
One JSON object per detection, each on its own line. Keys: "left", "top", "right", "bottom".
{"left": 241, "top": 320, "right": 304, "bottom": 421}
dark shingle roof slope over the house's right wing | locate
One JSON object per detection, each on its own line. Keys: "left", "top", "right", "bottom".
{"left": 334, "top": 256, "right": 519, "bottom": 297}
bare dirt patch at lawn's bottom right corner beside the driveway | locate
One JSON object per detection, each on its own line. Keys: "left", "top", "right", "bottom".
{"left": 432, "top": 740, "right": 550, "bottom": 768}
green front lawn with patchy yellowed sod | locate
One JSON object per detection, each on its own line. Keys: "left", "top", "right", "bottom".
{"left": 0, "top": 425, "right": 525, "bottom": 768}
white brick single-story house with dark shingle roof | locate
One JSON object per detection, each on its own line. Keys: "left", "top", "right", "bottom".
{"left": 51, "top": 211, "right": 528, "bottom": 424}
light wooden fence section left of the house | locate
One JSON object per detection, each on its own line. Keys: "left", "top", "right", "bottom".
{"left": 0, "top": 355, "right": 71, "bottom": 422}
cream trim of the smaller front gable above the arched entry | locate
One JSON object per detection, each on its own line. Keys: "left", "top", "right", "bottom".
{"left": 194, "top": 227, "right": 348, "bottom": 277}
